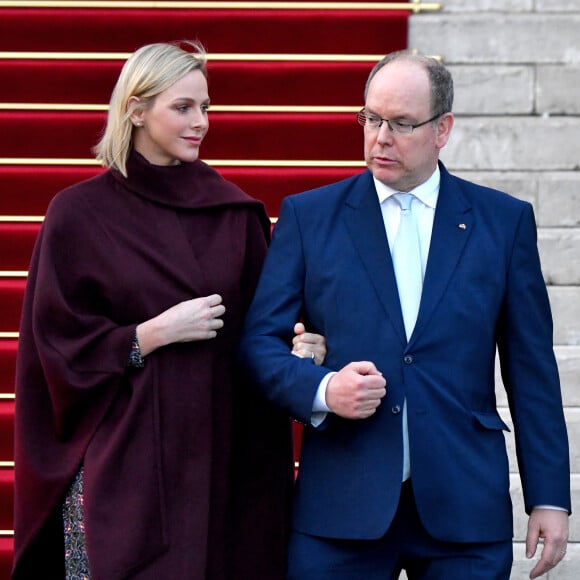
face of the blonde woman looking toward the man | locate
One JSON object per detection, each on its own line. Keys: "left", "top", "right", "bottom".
{"left": 131, "top": 70, "right": 209, "bottom": 165}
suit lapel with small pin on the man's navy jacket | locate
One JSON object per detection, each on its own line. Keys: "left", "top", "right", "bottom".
{"left": 410, "top": 164, "right": 474, "bottom": 342}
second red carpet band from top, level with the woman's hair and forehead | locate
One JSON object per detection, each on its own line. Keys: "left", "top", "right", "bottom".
{"left": 0, "top": 59, "right": 372, "bottom": 107}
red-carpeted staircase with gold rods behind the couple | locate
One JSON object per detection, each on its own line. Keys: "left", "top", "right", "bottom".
{"left": 0, "top": 0, "right": 439, "bottom": 580}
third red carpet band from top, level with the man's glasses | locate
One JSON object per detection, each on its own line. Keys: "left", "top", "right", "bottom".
{"left": 0, "top": 111, "right": 362, "bottom": 161}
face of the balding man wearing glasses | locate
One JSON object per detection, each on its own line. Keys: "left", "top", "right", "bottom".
{"left": 364, "top": 60, "right": 453, "bottom": 191}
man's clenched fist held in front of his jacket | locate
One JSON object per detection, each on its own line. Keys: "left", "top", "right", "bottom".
{"left": 326, "top": 361, "right": 387, "bottom": 419}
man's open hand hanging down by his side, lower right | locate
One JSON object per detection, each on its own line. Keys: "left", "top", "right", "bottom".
{"left": 526, "top": 508, "right": 568, "bottom": 578}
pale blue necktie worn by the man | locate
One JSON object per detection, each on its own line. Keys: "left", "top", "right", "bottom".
{"left": 392, "top": 193, "right": 423, "bottom": 481}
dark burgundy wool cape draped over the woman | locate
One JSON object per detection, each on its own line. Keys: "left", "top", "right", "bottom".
{"left": 13, "top": 152, "right": 293, "bottom": 580}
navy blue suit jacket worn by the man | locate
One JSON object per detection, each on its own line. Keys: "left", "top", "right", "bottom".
{"left": 240, "top": 164, "right": 570, "bottom": 542}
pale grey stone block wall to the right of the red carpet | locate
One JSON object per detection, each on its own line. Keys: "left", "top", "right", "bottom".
{"left": 408, "top": 0, "right": 580, "bottom": 580}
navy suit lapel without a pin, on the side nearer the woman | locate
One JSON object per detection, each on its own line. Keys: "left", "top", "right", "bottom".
{"left": 343, "top": 171, "right": 407, "bottom": 344}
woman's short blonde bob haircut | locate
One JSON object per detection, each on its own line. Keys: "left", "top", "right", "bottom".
{"left": 94, "top": 41, "right": 207, "bottom": 177}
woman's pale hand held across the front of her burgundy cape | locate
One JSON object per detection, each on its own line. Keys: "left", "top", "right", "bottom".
{"left": 137, "top": 294, "right": 226, "bottom": 356}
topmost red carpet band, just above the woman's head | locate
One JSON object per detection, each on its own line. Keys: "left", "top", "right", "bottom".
{"left": 0, "top": 7, "right": 407, "bottom": 54}
